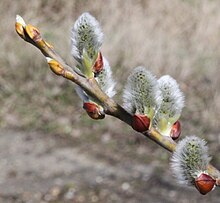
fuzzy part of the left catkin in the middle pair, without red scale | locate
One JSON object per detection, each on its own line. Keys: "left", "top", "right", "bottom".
{"left": 123, "top": 66, "right": 161, "bottom": 114}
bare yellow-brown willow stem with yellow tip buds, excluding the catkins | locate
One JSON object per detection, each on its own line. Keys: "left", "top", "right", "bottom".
{"left": 15, "top": 17, "right": 220, "bottom": 186}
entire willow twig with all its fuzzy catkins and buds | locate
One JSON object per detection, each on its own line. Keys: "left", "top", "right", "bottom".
{"left": 15, "top": 13, "right": 220, "bottom": 194}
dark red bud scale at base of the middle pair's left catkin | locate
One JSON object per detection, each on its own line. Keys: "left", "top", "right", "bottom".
{"left": 132, "top": 114, "right": 150, "bottom": 132}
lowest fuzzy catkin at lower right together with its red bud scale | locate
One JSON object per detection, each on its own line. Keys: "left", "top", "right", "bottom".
{"left": 171, "top": 136, "right": 216, "bottom": 195}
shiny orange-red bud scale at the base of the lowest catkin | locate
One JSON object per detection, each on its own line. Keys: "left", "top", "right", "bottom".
{"left": 195, "top": 173, "right": 216, "bottom": 195}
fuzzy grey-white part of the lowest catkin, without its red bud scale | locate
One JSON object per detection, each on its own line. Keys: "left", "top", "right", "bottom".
{"left": 170, "top": 136, "right": 211, "bottom": 185}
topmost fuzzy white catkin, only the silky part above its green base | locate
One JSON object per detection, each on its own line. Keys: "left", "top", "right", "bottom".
{"left": 71, "top": 12, "right": 103, "bottom": 63}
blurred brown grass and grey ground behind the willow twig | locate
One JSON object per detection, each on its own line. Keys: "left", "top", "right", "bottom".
{"left": 0, "top": 0, "right": 220, "bottom": 203}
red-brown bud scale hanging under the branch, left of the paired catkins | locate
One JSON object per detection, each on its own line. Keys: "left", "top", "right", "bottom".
{"left": 83, "top": 102, "right": 105, "bottom": 120}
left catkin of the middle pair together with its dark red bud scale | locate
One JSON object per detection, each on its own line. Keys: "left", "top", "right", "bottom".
{"left": 123, "top": 67, "right": 161, "bottom": 132}
